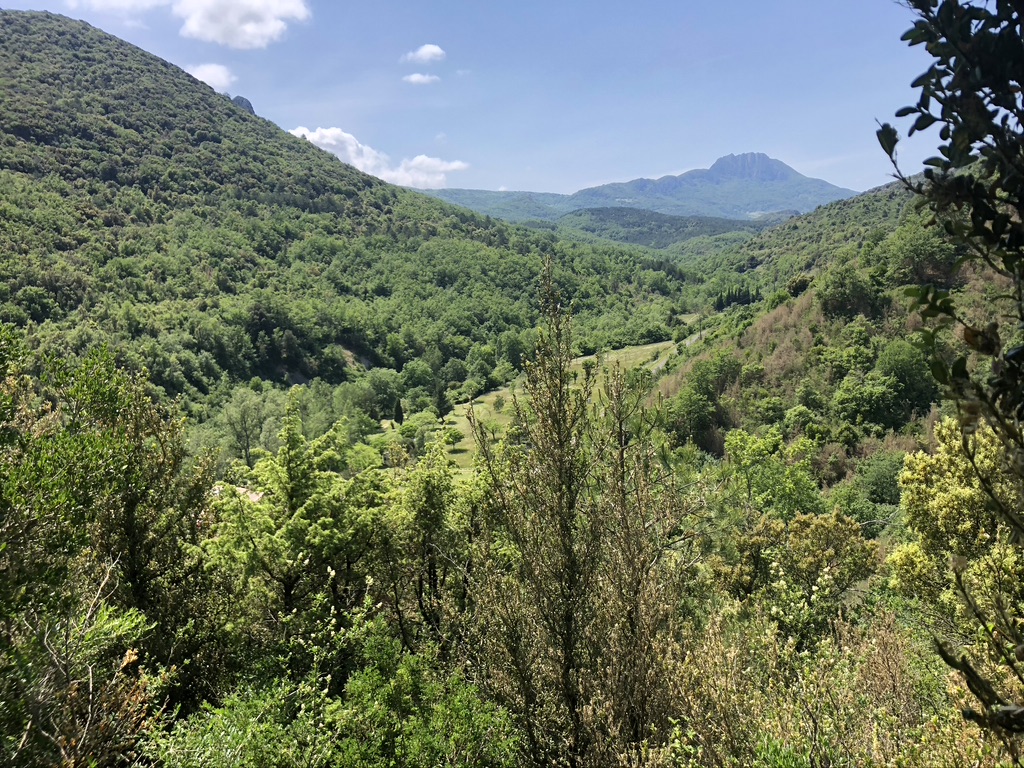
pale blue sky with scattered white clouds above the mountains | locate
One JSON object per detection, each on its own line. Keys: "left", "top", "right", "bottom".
{"left": 0, "top": 0, "right": 938, "bottom": 194}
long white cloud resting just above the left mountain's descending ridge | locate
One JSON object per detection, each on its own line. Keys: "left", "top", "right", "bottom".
{"left": 291, "top": 126, "right": 469, "bottom": 189}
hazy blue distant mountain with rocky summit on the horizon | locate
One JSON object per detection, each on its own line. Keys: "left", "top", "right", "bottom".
{"left": 419, "top": 153, "right": 857, "bottom": 221}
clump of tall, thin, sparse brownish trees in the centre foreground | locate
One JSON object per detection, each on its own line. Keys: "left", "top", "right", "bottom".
{"left": 473, "top": 296, "right": 692, "bottom": 768}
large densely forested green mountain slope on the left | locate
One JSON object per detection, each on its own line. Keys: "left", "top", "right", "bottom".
{"left": 0, "top": 11, "right": 681, "bottom": 416}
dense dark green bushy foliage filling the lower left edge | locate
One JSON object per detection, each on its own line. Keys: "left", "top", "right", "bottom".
{"left": 0, "top": 330, "right": 216, "bottom": 765}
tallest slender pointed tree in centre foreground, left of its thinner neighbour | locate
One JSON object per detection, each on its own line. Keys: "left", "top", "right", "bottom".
{"left": 473, "top": 303, "right": 604, "bottom": 768}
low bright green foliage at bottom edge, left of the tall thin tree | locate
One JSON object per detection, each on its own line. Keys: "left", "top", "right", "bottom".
{"left": 150, "top": 623, "right": 517, "bottom": 768}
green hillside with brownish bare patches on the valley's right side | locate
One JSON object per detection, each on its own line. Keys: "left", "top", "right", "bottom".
{"left": 658, "top": 176, "right": 966, "bottom": 468}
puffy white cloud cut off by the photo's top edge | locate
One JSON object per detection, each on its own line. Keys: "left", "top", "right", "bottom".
{"left": 173, "top": 0, "right": 310, "bottom": 48}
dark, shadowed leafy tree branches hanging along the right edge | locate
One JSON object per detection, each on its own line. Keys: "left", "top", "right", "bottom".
{"left": 878, "top": 0, "right": 1024, "bottom": 754}
